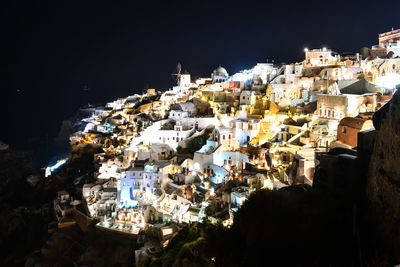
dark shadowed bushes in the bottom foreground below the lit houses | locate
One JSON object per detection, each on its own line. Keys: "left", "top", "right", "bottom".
{"left": 151, "top": 190, "right": 357, "bottom": 266}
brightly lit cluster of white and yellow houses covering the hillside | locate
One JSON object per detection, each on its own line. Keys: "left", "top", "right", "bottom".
{"left": 51, "top": 30, "right": 400, "bottom": 262}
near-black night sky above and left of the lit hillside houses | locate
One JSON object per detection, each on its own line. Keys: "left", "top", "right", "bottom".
{"left": 0, "top": 0, "right": 400, "bottom": 147}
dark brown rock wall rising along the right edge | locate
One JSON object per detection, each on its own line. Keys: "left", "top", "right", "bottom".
{"left": 367, "top": 90, "right": 400, "bottom": 262}
